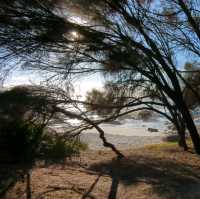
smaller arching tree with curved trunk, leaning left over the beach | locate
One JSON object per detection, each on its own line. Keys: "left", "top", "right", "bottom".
{"left": 85, "top": 79, "right": 188, "bottom": 150}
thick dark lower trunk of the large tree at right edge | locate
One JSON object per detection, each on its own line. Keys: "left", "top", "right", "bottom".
{"left": 179, "top": 102, "right": 200, "bottom": 154}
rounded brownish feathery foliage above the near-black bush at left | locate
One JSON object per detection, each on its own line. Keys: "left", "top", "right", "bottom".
{"left": 0, "top": 86, "right": 58, "bottom": 131}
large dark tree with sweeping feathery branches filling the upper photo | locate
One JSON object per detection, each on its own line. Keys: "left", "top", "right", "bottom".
{"left": 0, "top": 0, "right": 200, "bottom": 153}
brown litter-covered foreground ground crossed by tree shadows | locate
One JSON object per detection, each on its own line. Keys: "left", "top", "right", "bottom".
{"left": 2, "top": 143, "right": 200, "bottom": 199}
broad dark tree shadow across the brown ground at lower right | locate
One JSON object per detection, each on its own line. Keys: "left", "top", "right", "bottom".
{"left": 90, "top": 155, "right": 200, "bottom": 199}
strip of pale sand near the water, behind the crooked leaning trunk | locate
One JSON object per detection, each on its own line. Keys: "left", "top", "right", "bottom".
{"left": 81, "top": 125, "right": 169, "bottom": 150}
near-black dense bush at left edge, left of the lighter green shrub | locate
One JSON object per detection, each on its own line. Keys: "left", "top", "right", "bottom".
{"left": 0, "top": 121, "right": 42, "bottom": 161}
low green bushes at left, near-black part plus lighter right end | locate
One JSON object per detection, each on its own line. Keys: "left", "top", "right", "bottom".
{"left": 0, "top": 121, "right": 87, "bottom": 162}
